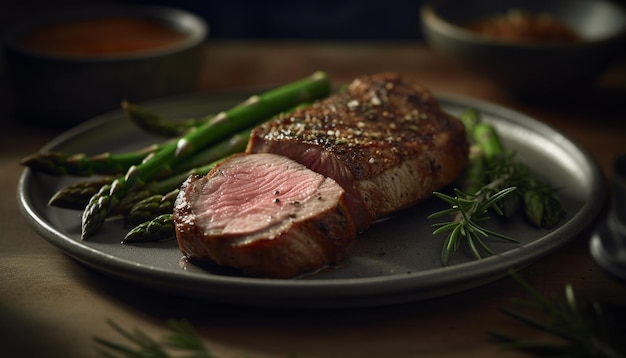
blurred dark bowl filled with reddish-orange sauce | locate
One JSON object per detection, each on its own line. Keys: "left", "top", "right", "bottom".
{"left": 4, "top": 5, "right": 208, "bottom": 127}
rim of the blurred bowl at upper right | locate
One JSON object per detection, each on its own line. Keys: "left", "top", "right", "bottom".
{"left": 420, "top": 0, "right": 626, "bottom": 49}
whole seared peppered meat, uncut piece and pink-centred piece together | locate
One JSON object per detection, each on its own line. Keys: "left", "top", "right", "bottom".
{"left": 174, "top": 73, "right": 468, "bottom": 278}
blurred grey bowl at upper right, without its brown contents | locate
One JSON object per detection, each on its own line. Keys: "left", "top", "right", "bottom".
{"left": 421, "top": 0, "right": 626, "bottom": 100}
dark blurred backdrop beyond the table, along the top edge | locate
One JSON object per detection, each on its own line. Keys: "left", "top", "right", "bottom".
{"left": 0, "top": 0, "right": 422, "bottom": 40}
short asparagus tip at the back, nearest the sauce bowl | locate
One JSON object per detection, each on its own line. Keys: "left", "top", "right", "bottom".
{"left": 122, "top": 101, "right": 207, "bottom": 138}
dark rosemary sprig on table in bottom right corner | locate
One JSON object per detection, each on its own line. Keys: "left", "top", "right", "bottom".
{"left": 489, "top": 273, "right": 626, "bottom": 358}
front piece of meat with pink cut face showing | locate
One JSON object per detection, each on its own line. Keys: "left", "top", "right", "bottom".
{"left": 174, "top": 153, "right": 356, "bottom": 278}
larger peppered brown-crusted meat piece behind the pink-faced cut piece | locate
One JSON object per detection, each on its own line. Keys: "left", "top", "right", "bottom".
{"left": 247, "top": 73, "right": 468, "bottom": 232}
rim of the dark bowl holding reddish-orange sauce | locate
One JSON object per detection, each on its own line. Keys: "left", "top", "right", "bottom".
{"left": 2, "top": 4, "right": 209, "bottom": 63}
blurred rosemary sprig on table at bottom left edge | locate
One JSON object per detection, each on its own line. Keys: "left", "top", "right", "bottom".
{"left": 93, "top": 319, "right": 214, "bottom": 358}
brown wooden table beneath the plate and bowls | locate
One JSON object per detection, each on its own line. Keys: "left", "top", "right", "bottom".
{"left": 0, "top": 42, "right": 626, "bottom": 358}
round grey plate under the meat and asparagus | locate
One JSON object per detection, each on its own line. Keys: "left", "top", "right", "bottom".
{"left": 18, "top": 94, "right": 606, "bottom": 308}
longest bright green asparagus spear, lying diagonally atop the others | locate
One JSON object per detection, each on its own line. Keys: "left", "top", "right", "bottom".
{"left": 81, "top": 72, "right": 330, "bottom": 239}
